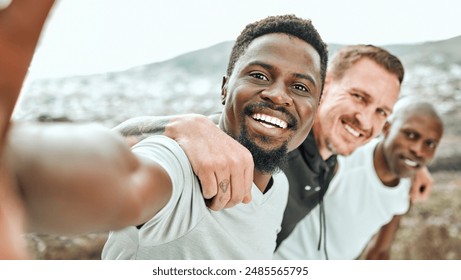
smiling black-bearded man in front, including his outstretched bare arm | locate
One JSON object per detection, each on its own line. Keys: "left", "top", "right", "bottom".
{"left": 0, "top": 15, "right": 328, "bottom": 259}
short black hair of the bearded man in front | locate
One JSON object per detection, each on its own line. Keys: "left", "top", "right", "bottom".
{"left": 227, "top": 15, "right": 328, "bottom": 93}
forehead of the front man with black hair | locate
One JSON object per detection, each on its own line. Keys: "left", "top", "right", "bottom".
{"left": 234, "top": 33, "right": 321, "bottom": 80}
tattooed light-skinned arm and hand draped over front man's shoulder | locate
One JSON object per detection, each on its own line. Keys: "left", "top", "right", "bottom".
{"left": 114, "top": 114, "right": 254, "bottom": 210}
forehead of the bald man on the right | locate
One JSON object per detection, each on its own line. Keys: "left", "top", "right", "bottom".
{"left": 397, "top": 112, "right": 443, "bottom": 141}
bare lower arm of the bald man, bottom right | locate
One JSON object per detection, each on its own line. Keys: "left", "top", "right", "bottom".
{"left": 364, "top": 215, "right": 402, "bottom": 260}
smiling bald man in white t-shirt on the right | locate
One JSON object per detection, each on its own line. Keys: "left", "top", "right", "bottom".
{"left": 275, "top": 98, "right": 443, "bottom": 260}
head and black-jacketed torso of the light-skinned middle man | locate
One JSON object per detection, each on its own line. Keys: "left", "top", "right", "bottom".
{"left": 277, "top": 45, "right": 404, "bottom": 244}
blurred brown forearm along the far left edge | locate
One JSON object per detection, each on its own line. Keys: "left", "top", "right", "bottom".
{"left": 0, "top": 0, "right": 54, "bottom": 259}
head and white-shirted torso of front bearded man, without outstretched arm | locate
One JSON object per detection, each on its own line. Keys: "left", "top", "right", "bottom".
{"left": 102, "top": 16, "right": 327, "bottom": 259}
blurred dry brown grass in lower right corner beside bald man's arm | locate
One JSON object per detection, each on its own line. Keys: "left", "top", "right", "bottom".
{"left": 391, "top": 172, "right": 461, "bottom": 260}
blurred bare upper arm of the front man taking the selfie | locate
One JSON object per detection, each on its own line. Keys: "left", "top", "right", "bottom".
{"left": 5, "top": 124, "right": 171, "bottom": 234}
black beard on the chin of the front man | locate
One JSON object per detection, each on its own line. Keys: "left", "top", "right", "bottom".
{"left": 237, "top": 124, "right": 288, "bottom": 174}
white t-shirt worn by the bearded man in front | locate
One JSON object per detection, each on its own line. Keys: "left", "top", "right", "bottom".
{"left": 102, "top": 136, "right": 288, "bottom": 259}
